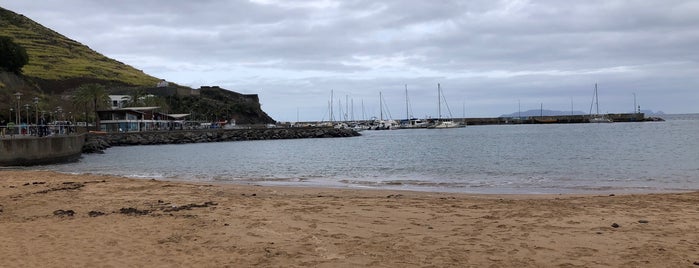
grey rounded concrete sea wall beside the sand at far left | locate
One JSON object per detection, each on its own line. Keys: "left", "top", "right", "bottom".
{"left": 0, "top": 134, "right": 85, "bottom": 166}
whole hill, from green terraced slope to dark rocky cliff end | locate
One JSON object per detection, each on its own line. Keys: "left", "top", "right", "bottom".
{"left": 0, "top": 7, "right": 274, "bottom": 124}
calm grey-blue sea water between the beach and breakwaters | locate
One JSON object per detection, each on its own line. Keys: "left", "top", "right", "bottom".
{"left": 39, "top": 115, "right": 699, "bottom": 194}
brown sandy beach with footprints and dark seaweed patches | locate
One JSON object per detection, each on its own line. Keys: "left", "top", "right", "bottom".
{"left": 0, "top": 170, "right": 699, "bottom": 267}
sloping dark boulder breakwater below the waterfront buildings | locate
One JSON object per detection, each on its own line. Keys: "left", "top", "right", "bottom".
{"left": 83, "top": 128, "right": 360, "bottom": 153}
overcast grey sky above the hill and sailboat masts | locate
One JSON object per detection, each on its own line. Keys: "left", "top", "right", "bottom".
{"left": 0, "top": 0, "right": 699, "bottom": 121}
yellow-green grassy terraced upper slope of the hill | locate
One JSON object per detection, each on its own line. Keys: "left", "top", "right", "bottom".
{"left": 0, "top": 7, "right": 160, "bottom": 86}
